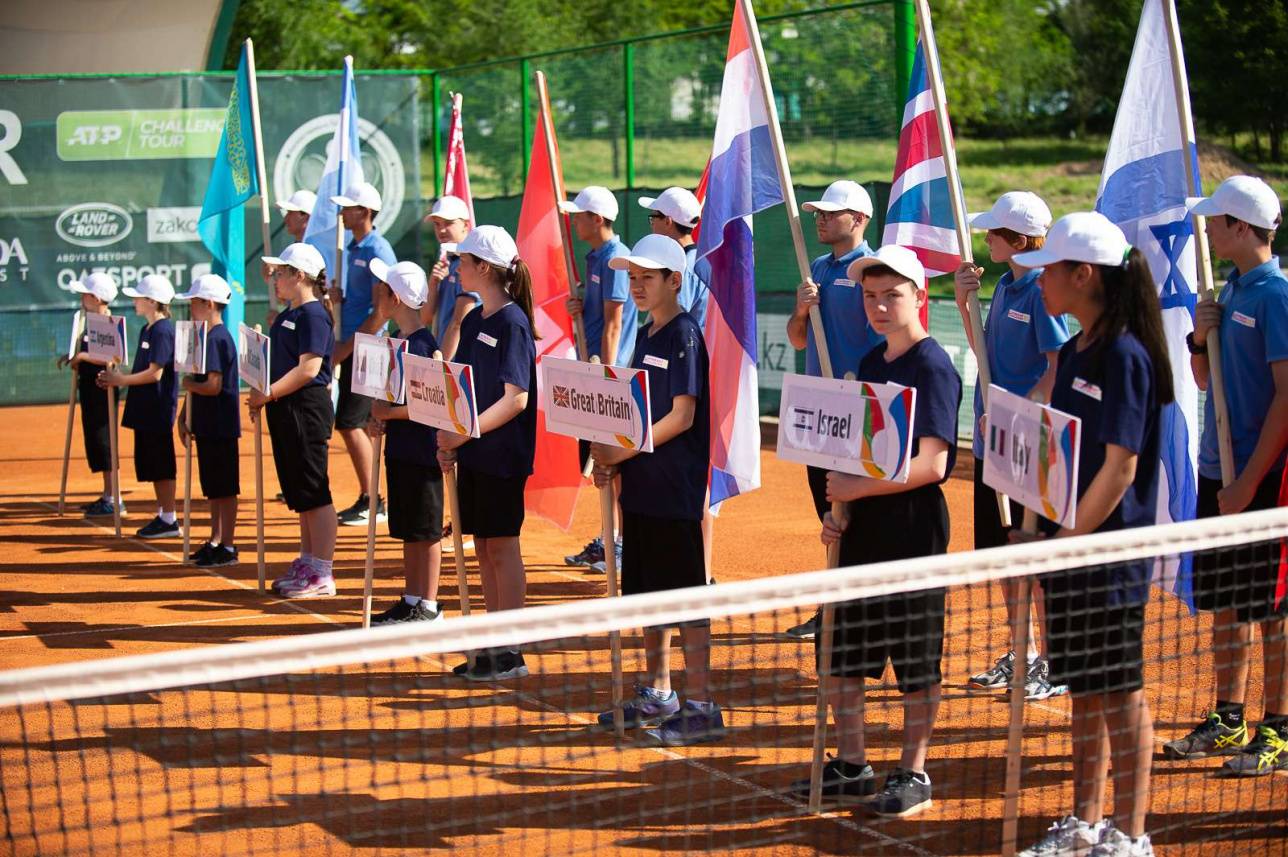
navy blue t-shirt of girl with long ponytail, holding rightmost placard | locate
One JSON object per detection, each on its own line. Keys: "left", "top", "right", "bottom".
{"left": 1041, "top": 332, "right": 1159, "bottom": 606}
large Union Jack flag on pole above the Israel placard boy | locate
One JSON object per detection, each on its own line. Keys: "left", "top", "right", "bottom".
{"left": 881, "top": 40, "right": 961, "bottom": 326}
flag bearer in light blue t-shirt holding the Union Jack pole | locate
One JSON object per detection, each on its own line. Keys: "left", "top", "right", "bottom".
{"left": 956, "top": 191, "right": 1069, "bottom": 700}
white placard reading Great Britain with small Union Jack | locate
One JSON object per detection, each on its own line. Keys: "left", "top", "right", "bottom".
{"left": 540, "top": 357, "right": 653, "bottom": 452}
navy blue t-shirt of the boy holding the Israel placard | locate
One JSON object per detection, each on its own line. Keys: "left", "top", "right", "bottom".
{"left": 858, "top": 336, "right": 962, "bottom": 483}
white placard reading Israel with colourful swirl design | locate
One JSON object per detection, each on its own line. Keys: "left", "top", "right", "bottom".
{"left": 778, "top": 374, "right": 917, "bottom": 482}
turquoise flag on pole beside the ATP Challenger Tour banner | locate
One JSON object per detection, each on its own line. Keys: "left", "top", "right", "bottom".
{"left": 197, "top": 45, "right": 259, "bottom": 330}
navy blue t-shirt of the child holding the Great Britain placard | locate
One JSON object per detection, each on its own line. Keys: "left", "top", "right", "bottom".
{"left": 621, "top": 312, "right": 711, "bottom": 521}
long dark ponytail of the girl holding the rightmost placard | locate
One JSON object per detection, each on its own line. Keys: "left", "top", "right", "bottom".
{"left": 1088, "top": 247, "right": 1176, "bottom": 405}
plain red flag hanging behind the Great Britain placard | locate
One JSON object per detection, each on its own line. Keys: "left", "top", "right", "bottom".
{"left": 516, "top": 73, "right": 582, "bottom": 530}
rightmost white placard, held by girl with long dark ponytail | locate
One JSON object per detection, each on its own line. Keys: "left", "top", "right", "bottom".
{"left": 984, "top": 384, "right": 1082, "bottom": 527}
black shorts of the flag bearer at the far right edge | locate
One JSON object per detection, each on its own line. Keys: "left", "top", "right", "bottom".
{"left": 1194, "top": 470, "right": 1288, "bottom": 622}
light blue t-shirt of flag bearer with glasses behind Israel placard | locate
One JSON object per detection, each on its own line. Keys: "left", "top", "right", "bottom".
{"left": 805, "top": 241, "right": 885, "bottom": 378}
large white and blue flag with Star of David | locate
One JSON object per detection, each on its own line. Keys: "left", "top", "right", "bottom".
{"left": 1096, "top": 0, "right": 1200, "bottom": 607}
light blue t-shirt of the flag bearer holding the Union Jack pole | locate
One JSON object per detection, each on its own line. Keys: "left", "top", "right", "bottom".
{"left": 974, "top": 268, "right": 1069, "bottom": 459}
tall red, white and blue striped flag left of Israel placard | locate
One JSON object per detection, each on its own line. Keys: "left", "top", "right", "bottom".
{"left": 698, "top": 0, "right": 783, "bottom": 506}
